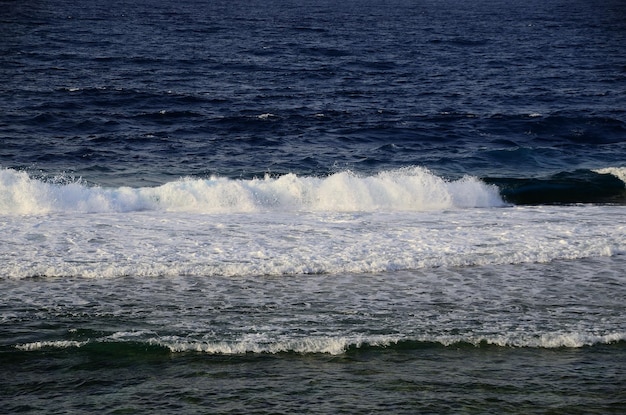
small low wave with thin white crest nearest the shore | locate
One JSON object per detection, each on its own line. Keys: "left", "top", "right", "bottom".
{"left": 15, "top": 332, "right": 626, "bottom": 356}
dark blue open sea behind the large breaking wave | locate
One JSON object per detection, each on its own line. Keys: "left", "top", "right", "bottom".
{"left": 0, "top": 0, "right": 626, "bottom": 186}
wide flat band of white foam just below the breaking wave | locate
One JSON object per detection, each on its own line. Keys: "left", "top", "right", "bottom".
{"left": 0, "top": 205, "right": 626, "bottom": 279}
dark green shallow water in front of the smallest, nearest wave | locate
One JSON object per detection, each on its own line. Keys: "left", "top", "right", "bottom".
{"left": 0, "top": 342, "right": 626, "bottom": 414}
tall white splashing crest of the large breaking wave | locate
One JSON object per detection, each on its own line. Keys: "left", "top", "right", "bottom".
{"left": 0, "top": 167, "right": 503, "bottom": 215}
